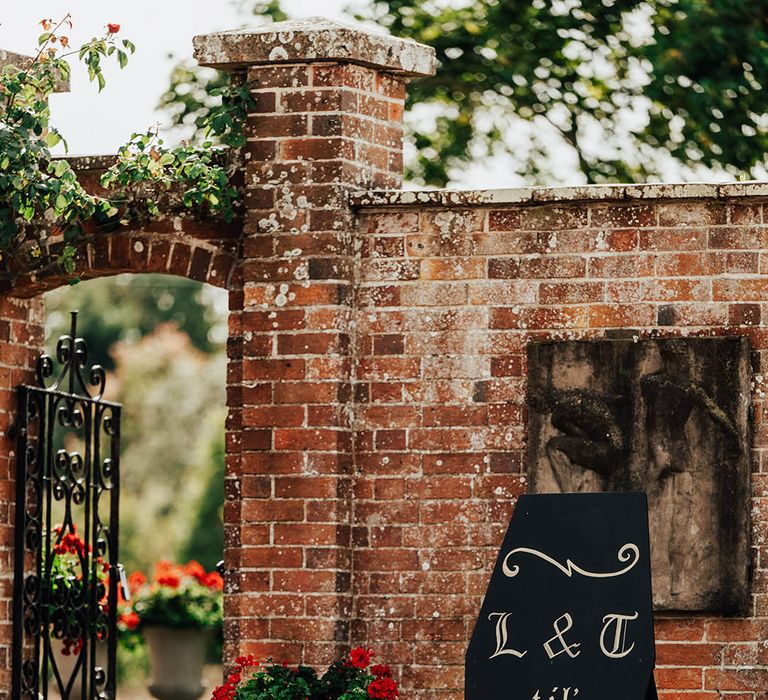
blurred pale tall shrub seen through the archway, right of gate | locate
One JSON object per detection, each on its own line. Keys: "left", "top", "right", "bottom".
{"left": 108, "top": 326, "right": 225, "bottom": 570}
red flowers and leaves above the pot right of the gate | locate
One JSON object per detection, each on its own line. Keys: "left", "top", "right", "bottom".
{"left": 118, "top": 561, "right": 224, "bottom": 631}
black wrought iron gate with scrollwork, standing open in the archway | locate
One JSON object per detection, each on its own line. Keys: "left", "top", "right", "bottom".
{"left": 13, "top": 312, "right": 124, "bottom": 700}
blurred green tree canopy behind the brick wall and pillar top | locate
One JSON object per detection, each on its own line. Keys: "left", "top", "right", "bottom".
{"left": 164, "top": 0, "right": 768, "bottom": 185}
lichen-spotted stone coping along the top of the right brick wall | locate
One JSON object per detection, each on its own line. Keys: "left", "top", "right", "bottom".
{"left": 350, "top": 181, "right": 768, "bottom": 208}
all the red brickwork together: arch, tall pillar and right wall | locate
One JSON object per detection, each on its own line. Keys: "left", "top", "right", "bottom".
{"left": 0, "top": 21, "right": 768, "bottom": 700}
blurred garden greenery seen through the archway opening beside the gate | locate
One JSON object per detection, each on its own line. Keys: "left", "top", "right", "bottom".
{"left": 45, "top": 275, "right": 227, "bottom": 700}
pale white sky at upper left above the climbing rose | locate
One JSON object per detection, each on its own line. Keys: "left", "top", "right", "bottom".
{"left": 0, "top": 0, "right": 352, "bottom": 155}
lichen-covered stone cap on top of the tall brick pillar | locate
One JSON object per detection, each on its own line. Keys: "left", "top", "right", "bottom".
{"left": 193, "top": 17, "right": 435, "bottom": 76}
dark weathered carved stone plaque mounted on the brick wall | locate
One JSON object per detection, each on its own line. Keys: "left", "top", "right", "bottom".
{"left": 528, "top": 337, "right": 750, "bottom": 614}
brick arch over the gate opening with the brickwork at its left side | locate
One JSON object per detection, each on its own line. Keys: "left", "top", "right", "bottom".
{"left": 0, "top": 198, "right": 242, "bottom": 698}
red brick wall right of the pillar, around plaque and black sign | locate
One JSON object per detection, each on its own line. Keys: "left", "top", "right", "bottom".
{"left": 353, "top": 198, "right": 768, "bottom": 700}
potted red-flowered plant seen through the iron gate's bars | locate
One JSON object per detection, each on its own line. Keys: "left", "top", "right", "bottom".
{"left": 44, "top": 523, "right": 109, "bottom": 697}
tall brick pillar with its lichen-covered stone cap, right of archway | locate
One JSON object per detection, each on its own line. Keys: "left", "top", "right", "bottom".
{"left": 195, "top": 15, "right": 434, "bottom": 664}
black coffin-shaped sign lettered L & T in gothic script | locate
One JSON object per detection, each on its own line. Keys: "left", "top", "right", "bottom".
{"left": 465, "top": 493, "right": 657, "bottom": 700}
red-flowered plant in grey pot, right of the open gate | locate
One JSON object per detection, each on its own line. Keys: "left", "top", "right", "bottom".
{"left": 119, "top": 561, "right": 224, "bottom": 700}
